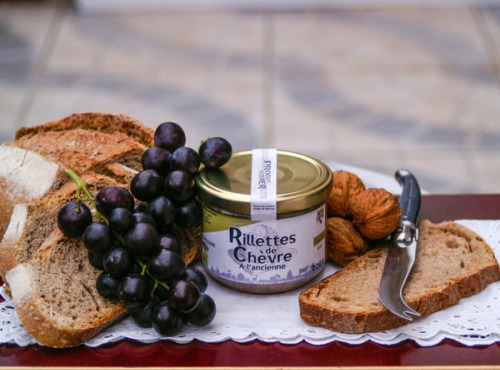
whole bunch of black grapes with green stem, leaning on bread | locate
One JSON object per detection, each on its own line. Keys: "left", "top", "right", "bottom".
{"left": 57, "top": 122, "right": 232, "bottom": 335}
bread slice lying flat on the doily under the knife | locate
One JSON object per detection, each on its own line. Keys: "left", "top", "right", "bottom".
{"left": 299, "top": 220, "right": 500, "bottom": 334}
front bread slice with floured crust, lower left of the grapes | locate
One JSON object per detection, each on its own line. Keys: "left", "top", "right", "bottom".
{"left": 6, "top": 229, "right": 127, "bottom": 348}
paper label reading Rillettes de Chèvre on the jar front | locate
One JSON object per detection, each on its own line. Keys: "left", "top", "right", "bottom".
{"left": 203, "top": 206, "right": 326, "bottom": 290}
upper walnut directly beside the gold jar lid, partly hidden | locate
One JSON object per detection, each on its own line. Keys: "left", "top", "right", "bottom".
{"left": 326, "top": 171, "right": 366, "bottom": 219}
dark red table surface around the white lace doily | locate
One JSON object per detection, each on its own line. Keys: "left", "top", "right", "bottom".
{"left": 0, "top": 194, "right": 500, "bottom": 367}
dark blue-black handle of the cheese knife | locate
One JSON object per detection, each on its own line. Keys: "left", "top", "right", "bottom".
{"left": 394, "top": 169, "right": 421, "bottom": 224}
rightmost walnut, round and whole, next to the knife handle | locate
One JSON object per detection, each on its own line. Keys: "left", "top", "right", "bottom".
{"left": 351, "top": 188, "right": 401, "bottom": 240}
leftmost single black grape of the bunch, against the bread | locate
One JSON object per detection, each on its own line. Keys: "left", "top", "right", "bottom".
{"left": 57, "top": 202, "right": 92, "bottom": 238}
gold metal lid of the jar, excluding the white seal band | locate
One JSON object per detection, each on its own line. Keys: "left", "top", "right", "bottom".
{"left": 196, "top": 150, "right": 332, "bottom": 215}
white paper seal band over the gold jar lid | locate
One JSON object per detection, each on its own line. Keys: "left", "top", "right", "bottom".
{"left": 250, "top": 149, "right": 278, "bottom": 221}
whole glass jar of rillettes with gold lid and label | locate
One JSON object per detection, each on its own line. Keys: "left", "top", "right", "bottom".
{"left": 196, "top": 149, "right": 332, "bottom": 293}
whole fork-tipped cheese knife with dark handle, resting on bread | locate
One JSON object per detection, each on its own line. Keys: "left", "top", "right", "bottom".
{"left": 379, "top": 169, "right": 421, "bottom": 321}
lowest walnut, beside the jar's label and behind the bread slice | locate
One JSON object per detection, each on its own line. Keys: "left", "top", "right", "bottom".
{"left": 326, "top": 217, "right": 369, "bottom": 267}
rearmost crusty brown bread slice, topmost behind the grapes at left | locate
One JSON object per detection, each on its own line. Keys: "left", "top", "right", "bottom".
{"left": 11, "top": 113, "right": 154, "bottom": 173}
